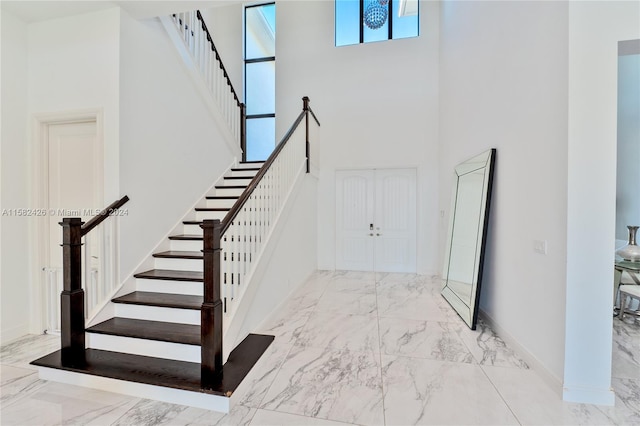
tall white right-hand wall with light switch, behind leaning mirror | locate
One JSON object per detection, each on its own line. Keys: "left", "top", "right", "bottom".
{"left": 439, "top": 1, "right": 568, "bottom": 388}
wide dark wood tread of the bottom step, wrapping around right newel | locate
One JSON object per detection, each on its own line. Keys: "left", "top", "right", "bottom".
{"left": 31, "top": 334, "right": 273, "bottom": 396}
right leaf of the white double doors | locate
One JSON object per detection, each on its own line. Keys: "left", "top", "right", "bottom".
{"left": 374, "top": 169, "right": 416, "bottom": 273}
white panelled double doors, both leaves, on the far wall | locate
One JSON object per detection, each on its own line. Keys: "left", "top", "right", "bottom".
{"left": 336, "top": 169, "right": 416, "bottom": 273}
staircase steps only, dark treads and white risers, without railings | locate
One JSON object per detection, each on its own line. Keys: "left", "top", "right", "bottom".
{"left": 32, "top": 162, "right": 273, "bottom": 412}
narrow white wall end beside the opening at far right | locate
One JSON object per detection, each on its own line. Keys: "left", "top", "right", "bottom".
{"left": 564, "top": 1, "right": 640, "bottom": 404}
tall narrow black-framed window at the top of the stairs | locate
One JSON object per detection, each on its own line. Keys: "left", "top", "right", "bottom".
{"left": 244, "top": 3, "right": 276, "bottom": 161}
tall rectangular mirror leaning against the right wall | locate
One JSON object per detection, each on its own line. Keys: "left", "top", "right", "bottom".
{"left": 442, "top": 149, "right": 496, "bottom": 330}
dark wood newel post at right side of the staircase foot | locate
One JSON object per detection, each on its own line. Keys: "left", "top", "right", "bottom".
{"left": 200, "top": 219, "right": 222, "bottom": 388}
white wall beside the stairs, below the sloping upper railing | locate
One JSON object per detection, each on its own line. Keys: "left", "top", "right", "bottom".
{"left": 120, "top": 11, "right": 238, "bottom": 278}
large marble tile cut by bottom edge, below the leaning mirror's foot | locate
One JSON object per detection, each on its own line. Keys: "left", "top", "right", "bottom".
{"left": 382, "top": 355, "right": 518, "bottom": 425}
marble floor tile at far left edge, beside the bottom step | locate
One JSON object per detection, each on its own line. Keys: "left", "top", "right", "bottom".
{"left": 0, "top": 334, "right": 60, "bottom": 370}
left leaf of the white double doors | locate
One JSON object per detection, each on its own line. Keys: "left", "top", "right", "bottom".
{"left": 336, "top": 170, "right": 375, "bottom": 271}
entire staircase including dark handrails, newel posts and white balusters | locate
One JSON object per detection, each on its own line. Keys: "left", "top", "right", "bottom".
{"left": 32, "top": 7, "right": 320, "bottom": 412}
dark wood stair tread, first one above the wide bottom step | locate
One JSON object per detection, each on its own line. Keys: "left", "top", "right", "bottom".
{"left": 87, "top": 317, "right": 201, "bottom": 346}
